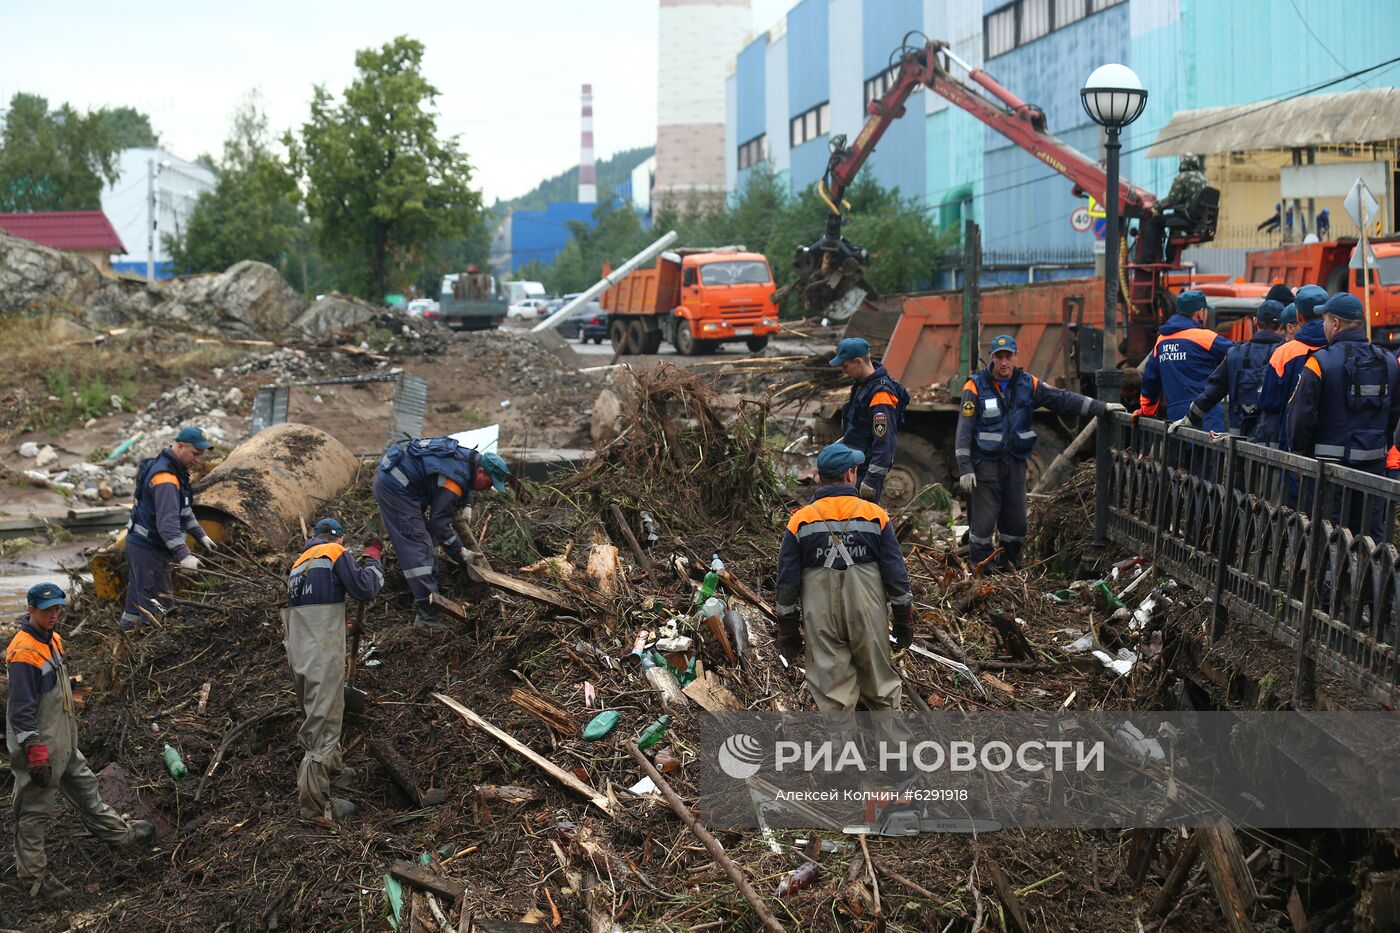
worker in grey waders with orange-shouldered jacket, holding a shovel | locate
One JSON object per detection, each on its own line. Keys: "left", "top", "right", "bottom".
{"left": 281, "top": 518, "right": 384, "bottom": 820}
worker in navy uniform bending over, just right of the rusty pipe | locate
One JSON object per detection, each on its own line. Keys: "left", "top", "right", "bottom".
{"left": 374, "top": 437, "right": 510, "bottom": 632}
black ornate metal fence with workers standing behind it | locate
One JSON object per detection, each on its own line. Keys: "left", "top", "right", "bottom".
{"left": 1099, "top": 415, "right": 1400, "bottom": 705}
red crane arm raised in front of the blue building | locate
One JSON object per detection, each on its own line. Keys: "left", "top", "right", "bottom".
{"left": 826, "top": 41, "right": 1156, "bottom": 217}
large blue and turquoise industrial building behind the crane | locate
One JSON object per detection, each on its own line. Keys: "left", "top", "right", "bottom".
{"left": 725, "top": 0, "right": 1400, "bottom": 282}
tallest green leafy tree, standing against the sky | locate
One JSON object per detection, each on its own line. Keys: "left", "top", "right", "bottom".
{"left": 286, "top": 36, "right": 482, "bottom": 300}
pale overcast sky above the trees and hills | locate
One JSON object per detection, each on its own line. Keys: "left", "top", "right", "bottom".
{"left": 0, "top": 0, "right": 795, "bottom": 202}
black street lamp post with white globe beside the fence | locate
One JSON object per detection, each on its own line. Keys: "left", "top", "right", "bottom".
{"left": 1079, "top": 64, "right": 1147, "bottom": 549}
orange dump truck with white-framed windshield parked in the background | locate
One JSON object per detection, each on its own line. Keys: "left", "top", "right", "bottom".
{"left": 601, "top": 247, "right": 778, "bottom": 356}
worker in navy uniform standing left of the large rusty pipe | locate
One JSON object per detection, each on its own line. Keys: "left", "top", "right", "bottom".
{"left": 122, "top": 427, "right": 214, "bottom": 630}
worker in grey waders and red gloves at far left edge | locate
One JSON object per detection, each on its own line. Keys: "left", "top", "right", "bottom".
{"left": 4, "top": 583, "right": 155, "bottom": 904}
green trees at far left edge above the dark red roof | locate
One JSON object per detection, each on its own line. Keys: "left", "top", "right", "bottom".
{"left": 0, "top": 92, "right": 120, "bottom": 212}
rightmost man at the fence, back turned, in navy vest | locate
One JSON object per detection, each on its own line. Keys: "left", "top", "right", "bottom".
{"left": 1288, "top": 291, "right": 1400, "bottom": 541}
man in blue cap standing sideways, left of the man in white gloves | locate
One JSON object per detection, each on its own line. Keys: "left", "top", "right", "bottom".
{"left": 832, "top": 338, "right": 909, "bottom": 502}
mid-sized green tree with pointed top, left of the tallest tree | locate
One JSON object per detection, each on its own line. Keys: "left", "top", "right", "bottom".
{"left": 165, "top": 94, "right": 308, "bottom": 277}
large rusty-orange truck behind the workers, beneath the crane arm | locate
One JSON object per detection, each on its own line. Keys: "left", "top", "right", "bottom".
{"left": 819, "top": 273, "right": 1268, "bottom": 507}
